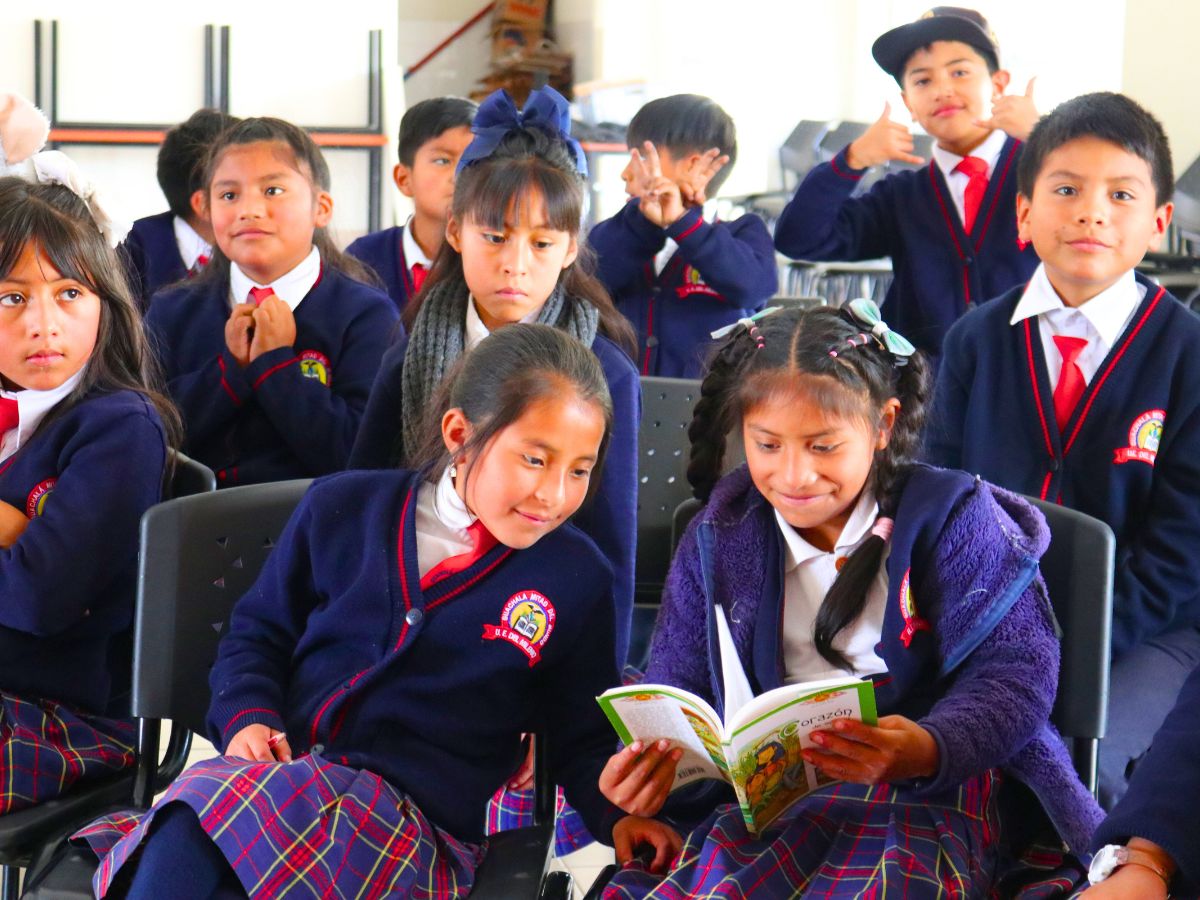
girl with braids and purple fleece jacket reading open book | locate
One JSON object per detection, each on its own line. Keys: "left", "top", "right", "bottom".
{"left": 601, "top": 301, "right": 1100, "bottom": 898}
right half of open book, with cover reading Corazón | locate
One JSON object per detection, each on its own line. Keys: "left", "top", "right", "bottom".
{"left": 728, "top": 679, "right": 876, "bottom": 834}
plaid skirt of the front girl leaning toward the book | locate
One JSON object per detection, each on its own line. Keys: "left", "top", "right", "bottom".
{"left": 72, "top": 755, "right": 484, "bottom": 900}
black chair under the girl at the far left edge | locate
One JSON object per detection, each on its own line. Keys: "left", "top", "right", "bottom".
{"left": 0, "top": 451, "right": 217, "bottom": 900}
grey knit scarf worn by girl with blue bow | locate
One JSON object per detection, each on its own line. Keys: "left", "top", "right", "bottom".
{"left": 394, "top": 275, "right": 600, "bottom": 464}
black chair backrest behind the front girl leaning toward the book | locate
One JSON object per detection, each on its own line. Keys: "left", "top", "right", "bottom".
{"left": 132, "top": 480, "right": 311, "bottom": 734}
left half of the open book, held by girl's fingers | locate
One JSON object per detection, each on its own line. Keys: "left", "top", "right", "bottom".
{"left": 596, "top": 684, "right": 728, "bottom": 791}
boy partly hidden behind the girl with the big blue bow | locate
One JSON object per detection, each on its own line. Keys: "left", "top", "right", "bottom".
{"left": 346, "top": 97, "right": 478, "bottom": 312}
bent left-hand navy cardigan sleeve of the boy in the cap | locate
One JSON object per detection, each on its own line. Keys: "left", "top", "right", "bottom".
{"left": 775, "top": 146, "right": 896, "bottom": 260}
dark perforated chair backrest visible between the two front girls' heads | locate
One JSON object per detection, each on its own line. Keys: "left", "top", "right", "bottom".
{"left": 636, "top": 376, "right": 700, "bottom": 599}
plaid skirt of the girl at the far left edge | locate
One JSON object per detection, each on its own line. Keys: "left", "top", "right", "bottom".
{"left": 0, "top": 691, "right": 136, "bottom": 815}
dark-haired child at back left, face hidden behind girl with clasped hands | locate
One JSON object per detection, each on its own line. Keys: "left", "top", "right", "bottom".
{"left": 121, "top": 109, "right": 235, "bottom": 312}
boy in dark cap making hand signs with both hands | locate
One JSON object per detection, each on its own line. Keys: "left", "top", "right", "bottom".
{"left": 775, "top": 6, "right": 1038, "bottom": 360}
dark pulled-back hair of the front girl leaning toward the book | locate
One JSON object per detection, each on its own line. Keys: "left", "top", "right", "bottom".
{"left": 413, "top": 323, "right": 612, "bottom": 494}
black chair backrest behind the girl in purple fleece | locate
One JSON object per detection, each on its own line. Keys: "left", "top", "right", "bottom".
{"left": 1026, "top": 497, "right": 1117, "bottom": 739}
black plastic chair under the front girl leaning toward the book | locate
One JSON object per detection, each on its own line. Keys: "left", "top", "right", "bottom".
{"left": 28, "top": 480, "right": 570, "bottom": 900}
